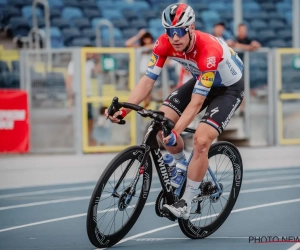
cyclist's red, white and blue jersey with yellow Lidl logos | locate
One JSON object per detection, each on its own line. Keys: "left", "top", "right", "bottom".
{"left": 146, "top": 31, "right": 243, "bottom": 96}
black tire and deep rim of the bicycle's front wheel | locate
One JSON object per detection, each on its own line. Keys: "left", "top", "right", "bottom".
{"left": 86, "top": 146, "right": 152, "bottom": 248}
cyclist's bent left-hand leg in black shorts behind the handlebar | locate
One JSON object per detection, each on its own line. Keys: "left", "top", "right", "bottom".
{"left": 158, "top": 78, "right": 196, "bottom": 155}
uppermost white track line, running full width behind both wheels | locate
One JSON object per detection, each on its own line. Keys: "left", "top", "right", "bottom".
{"left": 0, "top": 174, "right": 300, "bottom": 199}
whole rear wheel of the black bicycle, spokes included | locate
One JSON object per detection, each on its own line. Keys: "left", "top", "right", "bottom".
{"left": 178, "top": 142, "right": 243, "bottom": 239}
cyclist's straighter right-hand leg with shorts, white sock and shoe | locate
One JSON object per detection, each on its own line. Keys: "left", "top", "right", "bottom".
{"left": 167, "top": 80, "right": 244, "bottom": 219}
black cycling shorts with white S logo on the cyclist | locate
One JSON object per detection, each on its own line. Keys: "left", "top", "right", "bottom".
{"left": 163, "top": 78, "right": 244, "bottom": 134}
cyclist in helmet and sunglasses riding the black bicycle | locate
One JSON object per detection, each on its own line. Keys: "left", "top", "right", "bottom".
{"left": 106, "top": 3, "right": 244, "bottom": 219}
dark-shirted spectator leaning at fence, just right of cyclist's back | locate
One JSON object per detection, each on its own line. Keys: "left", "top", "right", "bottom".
{"left": 233, "top": 23, "right": 261, "bottom": 116}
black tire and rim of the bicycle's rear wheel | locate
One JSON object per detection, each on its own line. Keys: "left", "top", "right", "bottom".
{"left": 178, "top": 142, "right": 243, "bottom": 239}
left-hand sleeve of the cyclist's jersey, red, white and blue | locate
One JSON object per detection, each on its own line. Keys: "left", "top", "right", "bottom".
{"left": 145, "top": 35, "right": 168, "bottom": 80}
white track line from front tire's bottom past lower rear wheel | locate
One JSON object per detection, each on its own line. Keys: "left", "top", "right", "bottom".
{"left": 109, "top": 199, "right": 300, "bottom": 249}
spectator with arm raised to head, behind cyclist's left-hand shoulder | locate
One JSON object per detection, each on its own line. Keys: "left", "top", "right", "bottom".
{"left": 125, "top": 29, "right": 154, "bottom": 108}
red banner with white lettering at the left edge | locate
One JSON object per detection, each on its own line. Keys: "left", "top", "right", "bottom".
{"left": 0, "top": 89, "right": 29, "bottom": 153}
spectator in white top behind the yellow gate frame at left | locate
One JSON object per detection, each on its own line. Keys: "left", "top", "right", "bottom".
{"left": 65, "top": 45, "right": 101, "bottom": 145}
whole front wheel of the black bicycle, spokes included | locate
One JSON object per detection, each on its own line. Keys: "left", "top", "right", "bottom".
{"left": 86, "top": 146, "right": 152, "bottom": 248}
